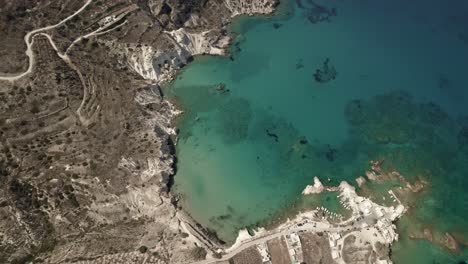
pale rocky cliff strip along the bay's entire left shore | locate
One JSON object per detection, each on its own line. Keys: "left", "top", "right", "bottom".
{"left": 113, "top": 0, "right": 279, "bottom": 256}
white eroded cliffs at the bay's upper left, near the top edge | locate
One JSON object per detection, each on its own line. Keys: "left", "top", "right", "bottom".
{"left": 123, "top": 0, "right": 278, "bottom": 83}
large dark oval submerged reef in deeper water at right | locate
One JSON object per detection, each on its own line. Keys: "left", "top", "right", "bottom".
{"left": 345, "top": 91, "right": 451, "bottom": 144}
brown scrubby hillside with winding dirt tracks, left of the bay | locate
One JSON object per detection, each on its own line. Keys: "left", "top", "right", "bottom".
{"left": 0, "top": 0, "right": 275, "bottom": 263}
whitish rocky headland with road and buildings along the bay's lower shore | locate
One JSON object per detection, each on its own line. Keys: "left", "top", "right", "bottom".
{"left": 192, "top": 177, "right": 405, "bottom": 264}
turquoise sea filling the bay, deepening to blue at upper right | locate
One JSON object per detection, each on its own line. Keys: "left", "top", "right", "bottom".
{"left": 164, "top": 0, "right": 468, "bottom": 263}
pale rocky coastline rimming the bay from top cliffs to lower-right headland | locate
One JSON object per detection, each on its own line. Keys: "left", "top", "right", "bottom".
{"left": 95, "top": 0, "right": 414, "bottom": 263}
